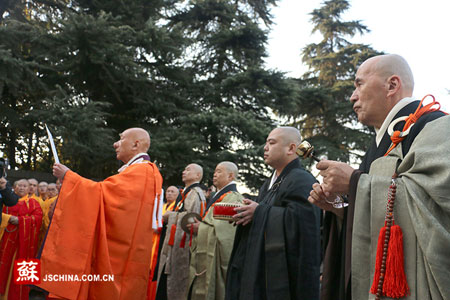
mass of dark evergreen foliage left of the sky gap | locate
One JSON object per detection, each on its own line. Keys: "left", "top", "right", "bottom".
{"left": 0, "top": 0, "right": 295, "bottom": 188}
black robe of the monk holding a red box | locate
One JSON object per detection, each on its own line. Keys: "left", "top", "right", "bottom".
{"left": 225, "top": 159, "right": 320, "bottom": 300}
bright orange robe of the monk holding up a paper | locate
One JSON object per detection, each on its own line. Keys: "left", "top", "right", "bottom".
{"left": 38, "top": 162, "right": 162, "bottom": 300}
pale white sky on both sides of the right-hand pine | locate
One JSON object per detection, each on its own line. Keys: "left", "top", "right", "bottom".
{"left": 266, "top": 0, "right": 450, "bottom": 112}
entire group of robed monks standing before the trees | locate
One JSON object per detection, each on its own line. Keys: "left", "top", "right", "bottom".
{"left": 0, "top": 54, "right": 450, "bottom": 300}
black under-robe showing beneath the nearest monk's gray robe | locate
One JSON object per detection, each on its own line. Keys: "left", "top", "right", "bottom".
{"left": 320, "top": 101, "right": 445, "bottom": 300}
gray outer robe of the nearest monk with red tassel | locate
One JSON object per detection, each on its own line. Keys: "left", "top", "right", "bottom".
{"left": 351, "top": 116, "right": 450, "bottom": 300}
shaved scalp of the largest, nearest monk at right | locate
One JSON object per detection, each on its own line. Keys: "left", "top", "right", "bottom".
{"left": 367, "top": 54, "right": 414, "bottom": 95}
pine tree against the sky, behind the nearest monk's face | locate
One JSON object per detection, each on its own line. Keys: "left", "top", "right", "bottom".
{"left": 282, "top": 0, "right": 380, "bottom": 162}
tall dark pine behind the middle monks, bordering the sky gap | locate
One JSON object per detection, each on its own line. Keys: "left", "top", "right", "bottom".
{"left": 156, "top": 0, "right": 293, "bottom": 188}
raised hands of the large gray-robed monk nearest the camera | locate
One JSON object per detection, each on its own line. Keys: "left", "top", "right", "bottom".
{"left": 316, "top": 160, "right": 354, "bottom": 198}
